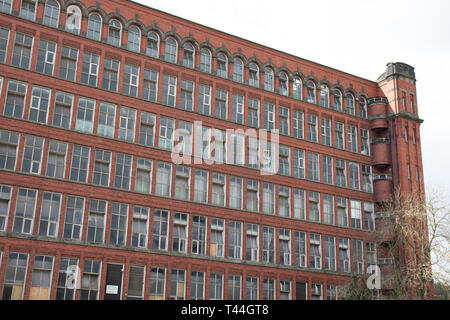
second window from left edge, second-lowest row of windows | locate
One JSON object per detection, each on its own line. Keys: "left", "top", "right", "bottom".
{"left": 12, "top": 188, "right": 37, "bottom": 234}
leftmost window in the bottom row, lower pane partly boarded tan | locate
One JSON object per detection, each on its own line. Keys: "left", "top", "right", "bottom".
{"left": 2, "top": 252, "right": 28, "bottom": 300}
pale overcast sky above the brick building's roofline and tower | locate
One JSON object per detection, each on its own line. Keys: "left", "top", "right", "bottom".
{"left": 135, "top": 0, "right": 450, "bottom": 198}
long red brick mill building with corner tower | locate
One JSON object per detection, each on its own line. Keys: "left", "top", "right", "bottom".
{"left": 0, "top": 0, "right": 424, "bottom": 300}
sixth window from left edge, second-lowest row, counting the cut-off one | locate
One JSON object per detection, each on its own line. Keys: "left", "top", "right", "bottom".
{"left": 109, "top": 202, "right": 128, "bottom": 246}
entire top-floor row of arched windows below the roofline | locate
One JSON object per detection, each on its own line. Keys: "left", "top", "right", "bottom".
{"left": 0, "top": 0, "right": 367, "bottom": 118}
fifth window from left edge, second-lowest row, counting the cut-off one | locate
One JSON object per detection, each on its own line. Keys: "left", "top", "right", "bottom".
{"left": 87, "top": 199, "right": 108, "bottom": 243}
